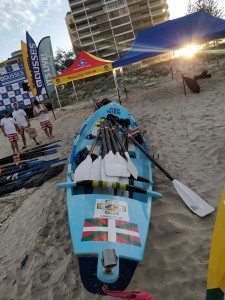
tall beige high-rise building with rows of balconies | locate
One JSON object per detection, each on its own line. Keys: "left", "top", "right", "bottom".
{"left": 68, "top": 0, "right": 169, "bottom": 60}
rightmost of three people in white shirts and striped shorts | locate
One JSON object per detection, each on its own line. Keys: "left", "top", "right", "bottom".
{"left": 33, "top": 100, "right": 54, "bottom": 139}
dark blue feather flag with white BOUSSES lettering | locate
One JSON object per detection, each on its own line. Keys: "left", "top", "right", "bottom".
{"left": 26, "top": 31, "right": 44, "bottom": 96}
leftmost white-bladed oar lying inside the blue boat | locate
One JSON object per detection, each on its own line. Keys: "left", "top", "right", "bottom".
{"left": 74, "top": 132, "right": 100, "bottom": 181}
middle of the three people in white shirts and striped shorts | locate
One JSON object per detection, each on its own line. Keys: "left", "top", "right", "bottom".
{"left": 12, "top": 102, "right": 40, "bottom": 149}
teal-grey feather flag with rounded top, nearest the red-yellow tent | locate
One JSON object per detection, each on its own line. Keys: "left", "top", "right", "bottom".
{"left": 38, "top": 36, "right": 57, "bottom": 97}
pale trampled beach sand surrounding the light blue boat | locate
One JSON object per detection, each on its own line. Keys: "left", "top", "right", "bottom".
{"left": 0, "top": 54, "right": 225, "bottom": 300}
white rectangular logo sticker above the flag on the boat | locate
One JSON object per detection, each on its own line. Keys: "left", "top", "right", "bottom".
{"left": 94, "top": 199, "right": 129, "bottom": 221}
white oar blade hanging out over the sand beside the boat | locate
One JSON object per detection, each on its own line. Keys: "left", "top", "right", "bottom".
{"left": 172, "top": 179, "right": 215, "bottom": 217}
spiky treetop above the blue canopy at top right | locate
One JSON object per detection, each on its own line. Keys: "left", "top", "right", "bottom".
{"left": 187, "top": 0, "right": 224, "bottom": 18}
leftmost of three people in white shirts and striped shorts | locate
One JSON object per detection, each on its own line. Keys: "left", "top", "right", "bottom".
{"left": 0, "top": 110, "right": 20, "bottom": 154}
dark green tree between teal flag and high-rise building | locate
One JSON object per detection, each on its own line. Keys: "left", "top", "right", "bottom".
{"left": 55, "top": 48, "right": 75, "bottom": 73}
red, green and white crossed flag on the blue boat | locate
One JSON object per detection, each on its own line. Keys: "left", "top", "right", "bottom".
{"left": 81, "top": 218, "right": 141, "bottom": 247}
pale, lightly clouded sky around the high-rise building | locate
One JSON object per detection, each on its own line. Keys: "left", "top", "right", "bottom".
{"left": 0, "top": 0, "right": 225, "bottom": 60}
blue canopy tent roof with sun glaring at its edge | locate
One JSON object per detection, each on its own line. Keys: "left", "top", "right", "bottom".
{"left": 112, "top": 11, "right": 225, "bottom": 68}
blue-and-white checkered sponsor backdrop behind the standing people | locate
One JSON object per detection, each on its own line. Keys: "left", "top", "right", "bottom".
{"left": 0, "top": 62, "right": 48, "bottom": 117}
